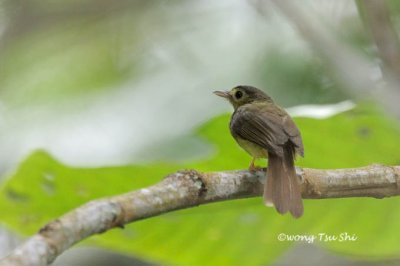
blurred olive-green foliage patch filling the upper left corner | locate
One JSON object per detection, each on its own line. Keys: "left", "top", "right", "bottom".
{"left": 0, "top": 0, "right": 162, "bottom": 110}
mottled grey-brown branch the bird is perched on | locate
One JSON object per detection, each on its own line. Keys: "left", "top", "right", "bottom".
{"left": 0, "top": 165, "right": 400, "bottom": 266}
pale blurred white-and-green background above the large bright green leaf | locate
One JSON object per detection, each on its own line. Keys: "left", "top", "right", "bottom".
{"left": 0, "top": 0, "right": 356, "bottom": 173}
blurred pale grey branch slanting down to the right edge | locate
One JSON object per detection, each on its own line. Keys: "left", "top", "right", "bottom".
{"left": 272, "top": 0, "right": 400, "bottom": 118}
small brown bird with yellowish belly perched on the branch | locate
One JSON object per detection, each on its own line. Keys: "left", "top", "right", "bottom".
{"left": 214, "top": 86, "right": 304, "bottom": 218}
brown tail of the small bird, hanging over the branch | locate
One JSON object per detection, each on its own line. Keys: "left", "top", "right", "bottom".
{"left": 264, "top": 144, "right": 303, "bottom": 218}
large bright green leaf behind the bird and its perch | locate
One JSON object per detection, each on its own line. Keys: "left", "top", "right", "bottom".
{"left": 0, "top": 104, "right": 400, "bottom": 265}
